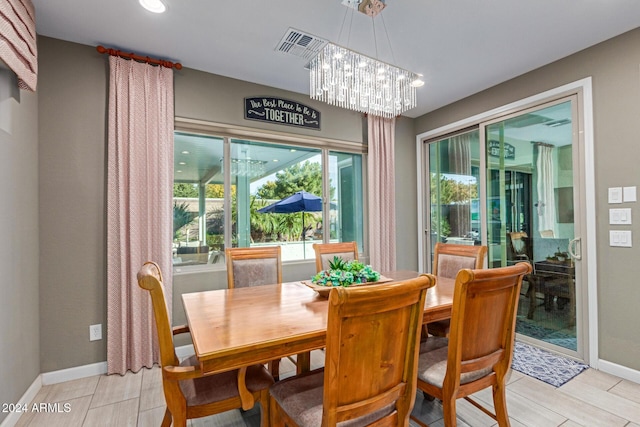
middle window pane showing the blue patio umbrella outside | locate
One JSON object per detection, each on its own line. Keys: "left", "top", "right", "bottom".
{"left": 230, "top": 139, "right": 323, "bottom": 261}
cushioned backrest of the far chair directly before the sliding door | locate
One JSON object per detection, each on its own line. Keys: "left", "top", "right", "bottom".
{"left": 432, "top": 242, "right": 487, "bottom": 279}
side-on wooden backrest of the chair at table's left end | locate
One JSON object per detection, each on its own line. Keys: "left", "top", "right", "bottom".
{"left": 138, "top": 261, "right": 180, "bottom": 366}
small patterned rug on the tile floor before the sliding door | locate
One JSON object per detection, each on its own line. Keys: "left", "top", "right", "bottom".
{"left": 511, "top": 341, "right": 588, "bottom": 387}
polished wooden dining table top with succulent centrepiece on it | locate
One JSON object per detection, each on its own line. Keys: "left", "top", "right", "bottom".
{"left": 182, "top": 271, "right": 455, "bottom": 373}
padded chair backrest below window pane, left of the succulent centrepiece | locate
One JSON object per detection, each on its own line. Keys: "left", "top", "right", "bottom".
{"left": 225, "top": 246, "right": 282, "bottom": 289}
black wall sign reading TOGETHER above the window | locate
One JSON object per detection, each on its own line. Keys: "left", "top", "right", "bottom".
{"left": 244, "top": 96, "right": 320, "bottom": 130}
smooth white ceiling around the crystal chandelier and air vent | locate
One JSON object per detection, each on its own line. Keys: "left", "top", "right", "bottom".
{"left": 33, "top": 0, "right": 640, "bottom": 117}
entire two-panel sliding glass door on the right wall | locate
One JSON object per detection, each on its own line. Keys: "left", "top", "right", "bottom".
{"left": 425, "top": 97, "right": 582, "bottom": 357}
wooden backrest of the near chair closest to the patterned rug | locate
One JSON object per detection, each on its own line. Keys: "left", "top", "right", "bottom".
{"left": 443, "top": 262, "right": 531, "bottom": 390}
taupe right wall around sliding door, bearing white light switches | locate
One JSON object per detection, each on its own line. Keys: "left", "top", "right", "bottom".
{"left": 415, "top": 29, "right": 640, "bottom": 370}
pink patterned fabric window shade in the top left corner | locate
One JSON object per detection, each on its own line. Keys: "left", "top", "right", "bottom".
{"left": 0, "top": 0, "right": 38, "bottom": 92}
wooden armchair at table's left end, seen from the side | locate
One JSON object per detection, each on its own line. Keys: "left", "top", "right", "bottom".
{"left": 138, "top": 262, "right": 273, "bottom": 426}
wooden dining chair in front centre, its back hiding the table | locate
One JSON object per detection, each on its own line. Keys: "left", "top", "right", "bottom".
{"left": 270, "top": 274, "right": 435, "bottom": 427}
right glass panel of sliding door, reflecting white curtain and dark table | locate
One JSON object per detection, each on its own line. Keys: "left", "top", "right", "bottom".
{"left": 481, "top": 100, "right": 578, "bottom": 353}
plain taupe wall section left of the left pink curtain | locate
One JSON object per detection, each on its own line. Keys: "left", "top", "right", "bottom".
{"left": 38, "top": 38, "right": 108, "bottom": 372}
